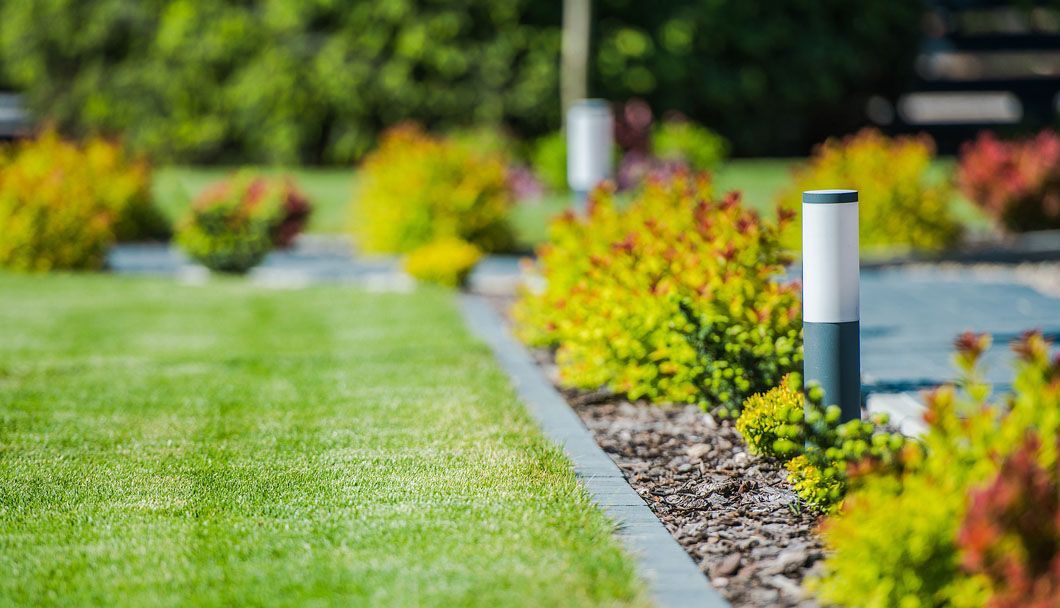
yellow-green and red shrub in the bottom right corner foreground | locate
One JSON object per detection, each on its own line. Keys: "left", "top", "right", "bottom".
{"left": 815, "top": 333, "right": 1060, "bottom": 606}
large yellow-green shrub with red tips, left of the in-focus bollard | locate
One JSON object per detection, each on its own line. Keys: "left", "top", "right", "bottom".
{"left": 513, "top": 173, "right": 802, "bottom": 415}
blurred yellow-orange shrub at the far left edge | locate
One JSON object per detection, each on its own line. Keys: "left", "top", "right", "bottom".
{"left": 0, "top": 131, "right": 169, "bottom": 271}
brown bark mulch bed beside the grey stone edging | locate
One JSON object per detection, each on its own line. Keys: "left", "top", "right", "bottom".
{"left": 535, "top": 352, "right": 824, "bottom": 607}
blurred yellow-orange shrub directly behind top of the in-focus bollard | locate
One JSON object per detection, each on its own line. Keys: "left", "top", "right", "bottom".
{"left": 777, "top": 129, "right": 960, "bottom": 252}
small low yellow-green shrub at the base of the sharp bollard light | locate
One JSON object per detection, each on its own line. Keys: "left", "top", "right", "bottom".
{"left": 736, "top": 374, "right": 906, "bottom": 512}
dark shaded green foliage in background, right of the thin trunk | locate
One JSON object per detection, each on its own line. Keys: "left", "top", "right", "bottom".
{"left": 593, "top": 0, "right": 923, "bottom": 155}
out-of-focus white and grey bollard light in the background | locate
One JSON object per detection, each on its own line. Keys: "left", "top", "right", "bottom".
{"left": 567, "top": 100, "right": 614, "bottom": 213}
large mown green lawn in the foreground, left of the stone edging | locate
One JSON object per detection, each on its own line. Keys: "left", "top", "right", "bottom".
{"left": 0, "top": 274, "right": 643, "bottom": 606}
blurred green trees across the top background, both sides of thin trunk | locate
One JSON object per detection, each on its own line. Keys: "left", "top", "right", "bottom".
{"left": 0, "top": 0, "right": 922, "bottom": 163}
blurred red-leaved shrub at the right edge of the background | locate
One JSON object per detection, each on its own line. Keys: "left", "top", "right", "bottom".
{"left": 957, "top": 131, "right": 1060, "bottom": 232}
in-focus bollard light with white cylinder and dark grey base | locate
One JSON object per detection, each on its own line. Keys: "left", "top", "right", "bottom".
{"left": 802, "top": 190, "right": 861, "bottom": 422}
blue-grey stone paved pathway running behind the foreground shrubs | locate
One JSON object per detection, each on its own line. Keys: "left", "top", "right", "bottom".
{"left": 108, "top": 235, "right": 1060, "bottom": 433}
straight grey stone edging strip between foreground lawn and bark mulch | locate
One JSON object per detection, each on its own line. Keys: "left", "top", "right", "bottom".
{"left": 460, "top": 294, "right": 728, "bottom": 608}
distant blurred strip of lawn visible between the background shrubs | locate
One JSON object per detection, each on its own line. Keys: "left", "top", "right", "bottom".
{"left": 155, "top": 158, "right": 990, "bottom": 250}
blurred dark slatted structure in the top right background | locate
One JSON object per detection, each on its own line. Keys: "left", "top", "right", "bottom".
{"left": 881, "top": 0, "right": 1060, "bottom": 153}
